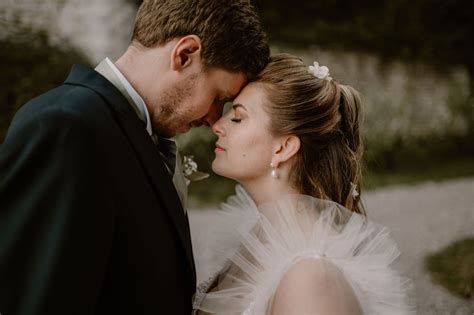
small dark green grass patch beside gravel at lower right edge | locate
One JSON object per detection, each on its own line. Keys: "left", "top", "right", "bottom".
{"left": 425, "top": 238, "right": 474, "bottom": 299}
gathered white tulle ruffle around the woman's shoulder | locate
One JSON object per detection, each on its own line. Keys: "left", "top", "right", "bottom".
{"left": 194, "top": 186, "right": 415, "bottom": 314}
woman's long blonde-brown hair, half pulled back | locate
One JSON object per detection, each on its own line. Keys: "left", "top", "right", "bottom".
{"left": 254, "top": 54, "right": 365, "bottom": 214}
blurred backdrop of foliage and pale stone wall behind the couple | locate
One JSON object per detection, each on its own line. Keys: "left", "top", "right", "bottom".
{"left": 0, "top": 0, "right": 474, "bottom": 206}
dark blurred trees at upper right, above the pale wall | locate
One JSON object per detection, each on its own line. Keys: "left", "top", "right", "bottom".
{"left": 256, "top": 0, "right": 474, "bottom": 135}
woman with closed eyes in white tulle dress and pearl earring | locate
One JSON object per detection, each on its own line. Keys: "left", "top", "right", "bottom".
{"left": 194, "top": 54, "right": 413, "bottom": 314}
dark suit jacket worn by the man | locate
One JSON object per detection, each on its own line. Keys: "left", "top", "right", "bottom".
{"left": 0, "top": 65, "right": 196, "bottom": 315}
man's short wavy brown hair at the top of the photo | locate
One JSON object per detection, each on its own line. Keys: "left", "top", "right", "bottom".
{"left": 132, "top": 0, "right": 270, "bottom": 80}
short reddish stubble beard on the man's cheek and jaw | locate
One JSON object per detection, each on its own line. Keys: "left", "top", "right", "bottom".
{"left": 150, "top": 74, "right": 199, "bottom": 138}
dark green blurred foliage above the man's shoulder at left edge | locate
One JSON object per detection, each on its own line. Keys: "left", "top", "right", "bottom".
{"left": 0, "top": 27, "right": 88, "bottom": 143}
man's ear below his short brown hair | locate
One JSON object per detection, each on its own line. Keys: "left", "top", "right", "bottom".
{"left": 170, "top": 35, "right": 202, "bottom": 71}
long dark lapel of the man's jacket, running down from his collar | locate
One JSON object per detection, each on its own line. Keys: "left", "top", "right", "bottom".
{"left": 66, "top": 65, "right": 195, "bottom": 274}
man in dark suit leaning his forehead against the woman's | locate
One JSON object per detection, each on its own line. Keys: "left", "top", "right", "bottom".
{"left": 0, "top": 0, "right": 269, "bottom": 315}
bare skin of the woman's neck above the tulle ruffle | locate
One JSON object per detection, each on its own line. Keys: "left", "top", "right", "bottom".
{"left": 241, "top": 176, "right": 299, "bottom": 206}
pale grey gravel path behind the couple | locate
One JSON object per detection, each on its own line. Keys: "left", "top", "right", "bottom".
{"left": 189, "top": 178, "right": 474, "bottom": 315}
